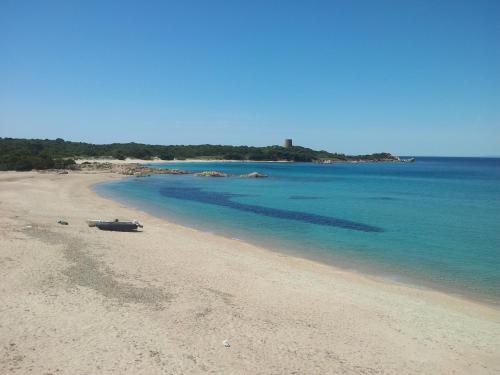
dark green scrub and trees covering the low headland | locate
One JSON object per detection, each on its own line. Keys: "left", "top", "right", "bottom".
{"left": 0, "top": 138, "right": 395, "bottom": 171}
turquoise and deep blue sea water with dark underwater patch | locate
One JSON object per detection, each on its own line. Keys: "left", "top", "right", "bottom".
{"left": 96, "top": 158, "right": 500, "bottom": 304}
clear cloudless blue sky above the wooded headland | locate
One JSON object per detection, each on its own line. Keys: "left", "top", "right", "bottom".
{"left": 0, "top": 0, "right": 500, "bottom": 156}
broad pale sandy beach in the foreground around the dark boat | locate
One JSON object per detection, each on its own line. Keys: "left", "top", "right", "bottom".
{"left": 0, "top": 172, "right": 500, "bottom": 375}
